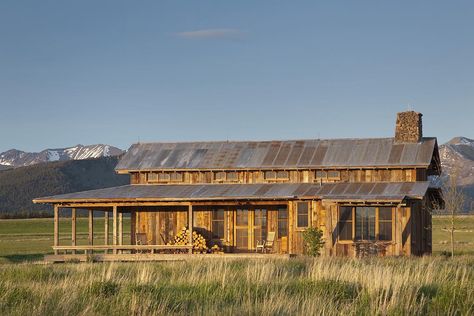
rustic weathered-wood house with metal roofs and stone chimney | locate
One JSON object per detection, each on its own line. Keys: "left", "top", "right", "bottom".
{"left": 34, "top": 111, "right": 442, "bottom": 260}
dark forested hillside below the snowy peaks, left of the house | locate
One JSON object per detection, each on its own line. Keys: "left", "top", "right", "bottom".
{"left": 0, "top": 157, "right": 129, "bottom": 217}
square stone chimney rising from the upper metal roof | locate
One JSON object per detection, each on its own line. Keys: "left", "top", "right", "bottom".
{"left": 395, "top": 111, "right": 423, "bottom": 143}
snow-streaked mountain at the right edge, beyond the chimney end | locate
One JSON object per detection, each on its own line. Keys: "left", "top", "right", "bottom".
{"left": 439, "top": 137, "right": 474, "bottom": 186}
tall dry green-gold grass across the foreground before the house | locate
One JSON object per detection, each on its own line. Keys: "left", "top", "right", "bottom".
{"left": 0, "top": 257, "right": 474, "bottom": 315}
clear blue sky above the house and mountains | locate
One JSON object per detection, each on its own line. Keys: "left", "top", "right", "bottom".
{"left": 0, "top": 0, "right": 474, "bottom": 151}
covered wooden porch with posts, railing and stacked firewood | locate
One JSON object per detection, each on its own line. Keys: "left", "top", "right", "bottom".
{"left": 45, "top": 201, "right": 291, "bottom": 262}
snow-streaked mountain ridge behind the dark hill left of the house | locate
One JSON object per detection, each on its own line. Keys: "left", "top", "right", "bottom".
{"left": 0, "top": 144, "right": 124, "bottom": 168}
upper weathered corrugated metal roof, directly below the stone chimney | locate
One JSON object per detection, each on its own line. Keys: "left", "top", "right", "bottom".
{"left": 116, "top": 138, "right": 436, "bottom": 171}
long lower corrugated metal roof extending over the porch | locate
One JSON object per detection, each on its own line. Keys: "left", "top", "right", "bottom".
{"left": 34, "top": 182, "right": 429, "bottom": 203}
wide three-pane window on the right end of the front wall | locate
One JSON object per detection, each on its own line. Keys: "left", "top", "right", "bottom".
{"left": 338, "top": 206, "right": 393, "bottom": 241}
